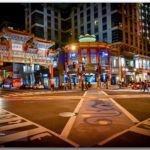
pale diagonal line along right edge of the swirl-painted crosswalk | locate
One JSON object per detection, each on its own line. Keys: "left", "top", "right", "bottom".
{"left": 102, "top": 91, "right": 140, "bottom": 123}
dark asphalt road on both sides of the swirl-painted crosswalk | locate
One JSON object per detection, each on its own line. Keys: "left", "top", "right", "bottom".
{"left": 0, "top": 90, "right": 150, "bottom": 147}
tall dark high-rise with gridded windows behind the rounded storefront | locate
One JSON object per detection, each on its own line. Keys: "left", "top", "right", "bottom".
{"left": 25, "top": 3, "right": 150, "bottom": 55}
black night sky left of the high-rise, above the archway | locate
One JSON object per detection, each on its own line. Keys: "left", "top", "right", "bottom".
{"left": 0, "top": 3, "right": 25, "bottom": 29}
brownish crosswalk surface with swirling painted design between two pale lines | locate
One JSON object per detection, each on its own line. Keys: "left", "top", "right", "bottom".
{"left": 63, "top": 89, "right": 136, "bottom": 147}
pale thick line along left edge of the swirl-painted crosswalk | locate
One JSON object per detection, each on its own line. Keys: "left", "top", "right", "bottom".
{"left": 60, "top": 91, "right": 87, "bottom": 138}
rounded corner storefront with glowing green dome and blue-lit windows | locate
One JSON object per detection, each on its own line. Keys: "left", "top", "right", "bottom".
{"left": 65, "top": 35, "right": 111, "bottom": 84}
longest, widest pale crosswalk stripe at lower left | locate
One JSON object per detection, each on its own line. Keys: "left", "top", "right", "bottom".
{"left": 0, "top": 128, "right": 45, "bottom": 144}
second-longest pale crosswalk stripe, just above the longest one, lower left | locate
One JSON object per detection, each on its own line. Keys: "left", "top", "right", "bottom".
{"left": 0, "top": 122, "right": 32, "bottom": 131}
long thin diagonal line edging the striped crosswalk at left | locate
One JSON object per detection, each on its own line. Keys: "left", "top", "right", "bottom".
{"left": 1, "top": 109, "right": 79, "bottom": 147}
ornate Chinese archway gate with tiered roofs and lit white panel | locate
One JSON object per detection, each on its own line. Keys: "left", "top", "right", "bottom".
{"left": 0, "top": 28, "right": 56, "bottom": 88}
